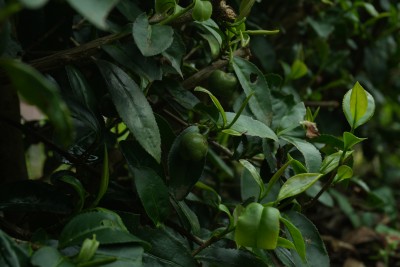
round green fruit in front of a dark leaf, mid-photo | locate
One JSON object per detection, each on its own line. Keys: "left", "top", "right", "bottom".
{"left": 179, "top": 132, "right": 208, "bottom": 161}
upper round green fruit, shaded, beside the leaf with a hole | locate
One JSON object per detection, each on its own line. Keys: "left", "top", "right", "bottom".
{"left": 208, "top": 70, "right": 238, "bottom": 96}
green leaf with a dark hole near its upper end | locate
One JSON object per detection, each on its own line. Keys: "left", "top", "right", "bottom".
{"left": 232, "top": 57, "right": 272, "bottom": 125}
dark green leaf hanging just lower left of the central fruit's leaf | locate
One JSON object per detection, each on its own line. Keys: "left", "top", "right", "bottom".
{"left": 131, "top": 168, "right": 171, "bottom": 226}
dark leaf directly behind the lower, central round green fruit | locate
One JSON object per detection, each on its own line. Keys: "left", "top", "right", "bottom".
{"left": 168, "top": 126, "right": 205, "bottom": 200}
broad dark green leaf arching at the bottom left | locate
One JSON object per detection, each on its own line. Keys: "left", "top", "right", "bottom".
{"left": 59, "top": 208, "right": 147, "bottom": 248}
